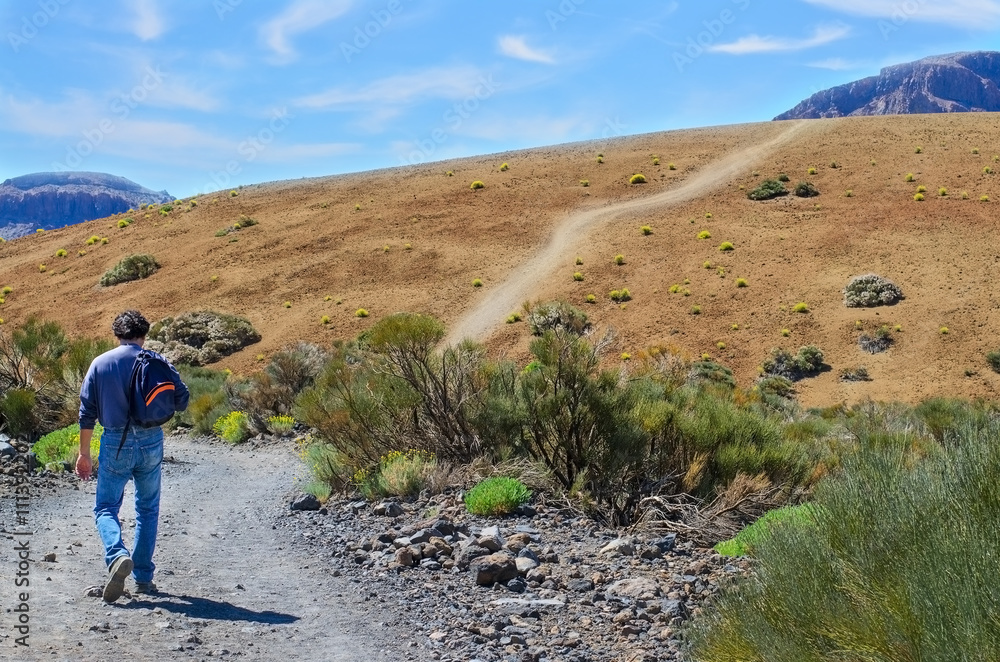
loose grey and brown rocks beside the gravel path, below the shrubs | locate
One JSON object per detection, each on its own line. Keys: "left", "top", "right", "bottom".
{"left": 280, "top": 494, "right": 747, "bottom": 662}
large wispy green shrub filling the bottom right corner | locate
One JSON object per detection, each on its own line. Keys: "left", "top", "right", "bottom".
{"left": 690, "top": 412, "right": 1000, "bottom": 662}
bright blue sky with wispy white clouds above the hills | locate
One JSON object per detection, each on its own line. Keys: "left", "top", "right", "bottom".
{"left": 0, "top": 0, "right": 1000, "bottom": 196}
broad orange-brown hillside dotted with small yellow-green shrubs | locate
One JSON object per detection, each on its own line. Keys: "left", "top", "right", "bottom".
{"left": 0, "top": 113, "right": 1000, "bottom": 405}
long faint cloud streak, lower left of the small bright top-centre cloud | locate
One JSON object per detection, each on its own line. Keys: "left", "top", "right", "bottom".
{"left": 293, "top": 66, "right": 496, "bottom": 110}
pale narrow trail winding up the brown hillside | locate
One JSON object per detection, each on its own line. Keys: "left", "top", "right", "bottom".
{"left": 445, "top": 120, "right": 824, "bottom": 345}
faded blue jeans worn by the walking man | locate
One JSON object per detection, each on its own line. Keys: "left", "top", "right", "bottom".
{"left": 94, "top": 428, "right": 163, "bottom": 582}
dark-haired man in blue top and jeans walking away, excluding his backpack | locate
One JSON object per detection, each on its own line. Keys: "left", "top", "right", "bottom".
{"left": 76, "top": 310, "right": 189, "bottom": 602}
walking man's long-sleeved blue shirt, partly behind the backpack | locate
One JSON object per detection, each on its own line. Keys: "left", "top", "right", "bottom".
{"left": 80, "top": 342, "right": 190, "bottom": 430}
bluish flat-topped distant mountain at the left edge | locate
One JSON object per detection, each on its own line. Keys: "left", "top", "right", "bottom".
{"left": 0, "top": 172, "right": 173, "bottom": 239}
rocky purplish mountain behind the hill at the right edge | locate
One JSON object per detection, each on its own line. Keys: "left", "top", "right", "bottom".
{"left": 774, "top": 51, "right": 1000, "bottom": 120}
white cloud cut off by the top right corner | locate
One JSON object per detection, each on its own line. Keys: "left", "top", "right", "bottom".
{"left": 803, "top": 0, "right": 1000, "bottom": 30}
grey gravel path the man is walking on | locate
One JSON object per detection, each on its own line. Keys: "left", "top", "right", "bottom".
{"left": 0, "top": 437, "right": 405, "bottom": 662}
